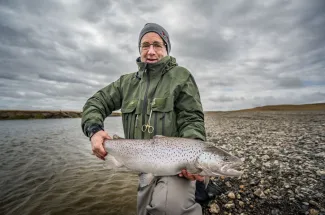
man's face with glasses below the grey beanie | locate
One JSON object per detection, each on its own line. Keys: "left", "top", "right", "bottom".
{"left": 140, "top": 32, "right": 167, "bottom": 63}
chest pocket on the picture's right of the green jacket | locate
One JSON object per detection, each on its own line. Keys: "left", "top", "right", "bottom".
{"left": 147, "top": 96, "right": 177, "bottom": 136}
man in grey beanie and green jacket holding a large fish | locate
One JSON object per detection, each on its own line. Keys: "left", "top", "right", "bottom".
{"left": 82, "top": 23, "right": 206, "bottom": 215}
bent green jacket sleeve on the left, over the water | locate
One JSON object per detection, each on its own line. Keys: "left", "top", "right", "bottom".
{"left": 81, "top": 77, "right": 122, "bottom": 136}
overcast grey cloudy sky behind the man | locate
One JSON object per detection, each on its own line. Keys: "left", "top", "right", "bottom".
{"left": 0, "top": 0, "right": 325, "bottom": 111}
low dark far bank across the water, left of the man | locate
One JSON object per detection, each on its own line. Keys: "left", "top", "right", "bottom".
{"left": 0, "top": 110, "right": 121, "bottom": 120}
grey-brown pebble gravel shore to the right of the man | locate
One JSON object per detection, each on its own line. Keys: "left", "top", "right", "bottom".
{"left": 204, "top": 111, "right": 325, "bottom": 215}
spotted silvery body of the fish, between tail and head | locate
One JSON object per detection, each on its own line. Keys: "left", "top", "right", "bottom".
{"left": 105, "top": 137, "right": 205, "bottom": 176}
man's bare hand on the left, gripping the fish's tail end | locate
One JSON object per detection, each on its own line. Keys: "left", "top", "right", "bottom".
{"left": 90, "top": 131, "right": 112, "bottom": 160}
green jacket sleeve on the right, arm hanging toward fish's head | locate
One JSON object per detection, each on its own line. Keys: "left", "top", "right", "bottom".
{"left": 175, "top": 74, "right": 206, "bottom": 141}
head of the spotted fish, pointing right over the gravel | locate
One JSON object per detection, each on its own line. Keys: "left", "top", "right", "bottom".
{"left": 196, "top": 146, "right": 243, "bottom": 177}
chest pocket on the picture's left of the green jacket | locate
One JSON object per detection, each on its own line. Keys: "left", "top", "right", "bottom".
{"left": 121, "top": 99, "right": 141, "bottom": 139}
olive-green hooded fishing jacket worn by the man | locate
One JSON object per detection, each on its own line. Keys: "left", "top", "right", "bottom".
{"left": 81, "top": 56, "right": 206, "bottom": 140}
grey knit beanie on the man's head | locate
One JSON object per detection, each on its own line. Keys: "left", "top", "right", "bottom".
{"left": 138, "top": 23, "right": 171, "bottom": 54}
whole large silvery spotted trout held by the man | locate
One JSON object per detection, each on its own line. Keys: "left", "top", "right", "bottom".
{"left": 104, "top": 135, "right": 243, "bottom": 187}
